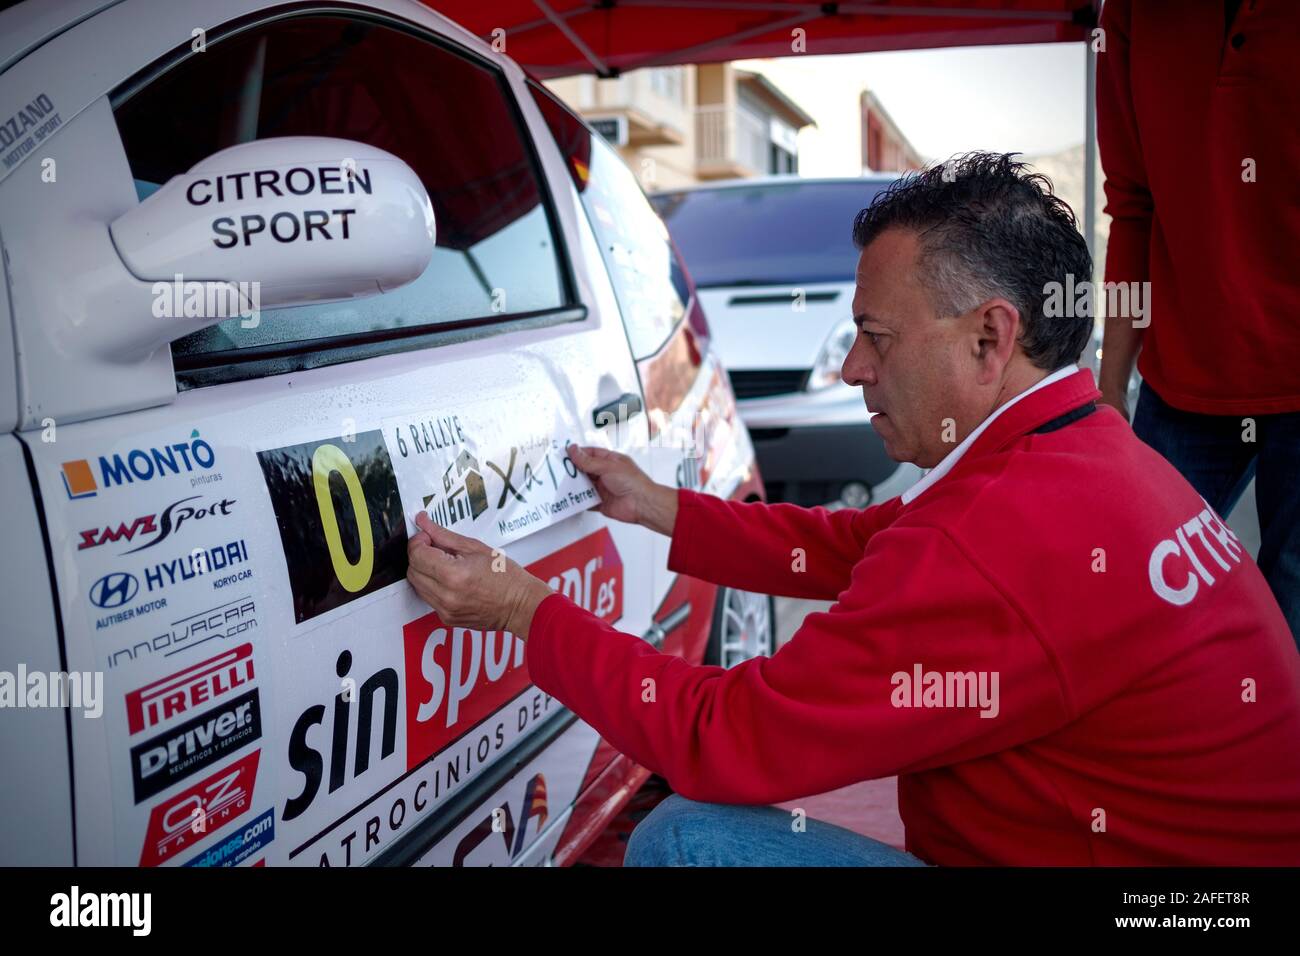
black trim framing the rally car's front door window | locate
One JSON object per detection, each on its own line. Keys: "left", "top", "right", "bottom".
{"left": 109, "top": 0, "right": 588, "bottom": 392}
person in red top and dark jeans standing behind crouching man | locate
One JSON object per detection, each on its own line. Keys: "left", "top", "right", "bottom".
{"left": 1097, "top": 0, "right": 1300, "bottom": 644}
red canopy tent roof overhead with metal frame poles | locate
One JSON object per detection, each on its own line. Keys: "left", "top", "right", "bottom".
{"left": 436, "top": 0, "right": 1101, "bottom": 77}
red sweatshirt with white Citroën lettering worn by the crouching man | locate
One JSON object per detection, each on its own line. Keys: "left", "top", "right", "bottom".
{"left": 527, "top": 369, "right": 1300, "bottom": 865}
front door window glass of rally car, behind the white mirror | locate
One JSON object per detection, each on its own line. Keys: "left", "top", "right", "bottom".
{"left": 114, "top": 16, "right": 568, "bottom": 358}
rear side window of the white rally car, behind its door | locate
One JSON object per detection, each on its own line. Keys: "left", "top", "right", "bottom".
{"left": 529, "top": 83, "right": 690, "bottom": 359}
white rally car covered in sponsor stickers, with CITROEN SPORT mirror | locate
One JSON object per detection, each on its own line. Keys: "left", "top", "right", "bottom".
{"left": 0, "top": 0, "right": 772, "bottom": 866}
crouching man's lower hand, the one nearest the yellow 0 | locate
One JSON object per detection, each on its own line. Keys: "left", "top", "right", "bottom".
{"left": 407, "top": 511, "right": 551, "bottom": 639}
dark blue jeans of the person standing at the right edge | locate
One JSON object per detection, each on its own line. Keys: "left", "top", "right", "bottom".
{"left": 1134, "top": 382, "right": 1300, "bottom": 646}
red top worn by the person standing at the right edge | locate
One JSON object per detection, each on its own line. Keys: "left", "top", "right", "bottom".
{"left": 1097, "top": 0, "right": 1300, "bottom": 415}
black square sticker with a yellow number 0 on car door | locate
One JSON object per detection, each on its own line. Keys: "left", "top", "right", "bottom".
{"left": 257, "top": 432, "right": 407, "bottom": 623}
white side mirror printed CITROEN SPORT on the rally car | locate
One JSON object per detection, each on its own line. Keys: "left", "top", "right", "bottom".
{"left": 109, "top": 137, "right": 436, "bottom": 354}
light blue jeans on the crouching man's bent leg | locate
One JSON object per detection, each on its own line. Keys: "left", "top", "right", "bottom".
{"left": 623, "top": 793, "right": 926, "bottom": 866}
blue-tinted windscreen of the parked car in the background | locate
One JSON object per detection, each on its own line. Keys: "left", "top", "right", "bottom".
{"left": 651, "top": 179, "right": 888, "bottom": 289}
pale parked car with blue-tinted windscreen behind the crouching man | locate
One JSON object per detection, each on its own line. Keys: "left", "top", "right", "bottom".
{"left": 651, "top": 174, "right": 920, "bottom": 507}
